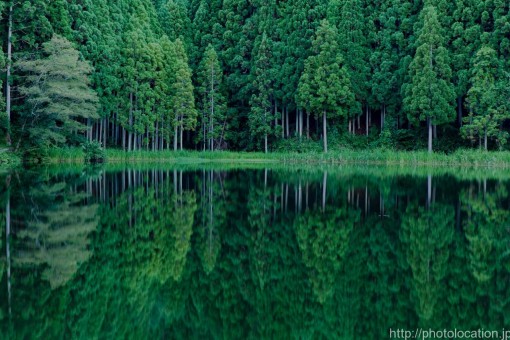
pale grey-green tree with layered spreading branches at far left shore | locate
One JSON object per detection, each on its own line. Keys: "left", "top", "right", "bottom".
{"left": 16, "top": 35, "right": 98, "bottom": 147}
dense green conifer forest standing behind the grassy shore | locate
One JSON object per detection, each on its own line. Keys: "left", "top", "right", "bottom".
{"left": 0, "top": 0, "right": 510, "bottom": 152}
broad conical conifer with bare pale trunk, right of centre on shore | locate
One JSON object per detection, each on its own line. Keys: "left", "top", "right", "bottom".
{"left": 297, "top": 20, "right": 354, "bottom": 152}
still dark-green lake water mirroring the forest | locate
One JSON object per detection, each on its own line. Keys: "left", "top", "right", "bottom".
{"left": 0, "top": 166, "right": 510, "bottom": 339}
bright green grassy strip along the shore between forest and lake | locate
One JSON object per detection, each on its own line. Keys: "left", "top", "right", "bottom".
{"left": 42, "top": 148, "right": 510, "bottom": 168}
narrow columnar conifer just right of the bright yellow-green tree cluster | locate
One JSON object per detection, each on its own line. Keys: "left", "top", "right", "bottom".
{"left": 198, "top": 44, "right": 226, "bottom": 151}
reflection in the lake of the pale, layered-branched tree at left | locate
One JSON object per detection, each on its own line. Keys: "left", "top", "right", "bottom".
{"left": 14, "top": 182, "right": 98, "bottom": 289}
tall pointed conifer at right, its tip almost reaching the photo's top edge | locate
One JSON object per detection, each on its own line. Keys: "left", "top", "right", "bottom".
{"left": 403, "top": 6, "right": 455, "bottom": 152}
